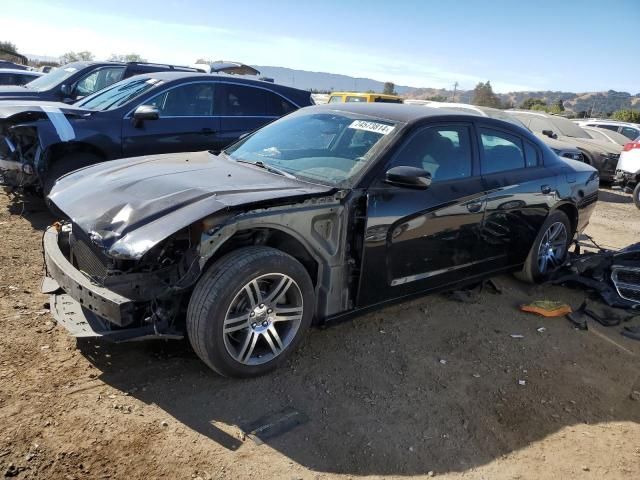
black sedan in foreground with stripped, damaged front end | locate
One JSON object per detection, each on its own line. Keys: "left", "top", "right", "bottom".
{"left": 44, "top": 104, "right": 598, "bottom": 376}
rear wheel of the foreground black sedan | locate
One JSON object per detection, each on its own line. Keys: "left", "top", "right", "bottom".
{"left": 516, "top": 210, "right": 573, "bottom": 283}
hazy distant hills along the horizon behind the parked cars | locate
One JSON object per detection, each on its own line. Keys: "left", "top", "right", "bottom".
{"left": 254, "top": 65, "right": 640, "bottom": 113}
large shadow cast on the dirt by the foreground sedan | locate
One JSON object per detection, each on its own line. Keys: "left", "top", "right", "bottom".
{"left": 72, "top": 280, "right": 640, "bottom": 476}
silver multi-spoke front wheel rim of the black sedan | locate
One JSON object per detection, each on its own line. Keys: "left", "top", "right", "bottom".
{"left": 223, "top": 273, "right": 304, "bottom": 365}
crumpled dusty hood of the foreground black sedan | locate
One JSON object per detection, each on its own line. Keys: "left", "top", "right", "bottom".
{"left": 48, "top": 152, "right": 334, "bottom": 259}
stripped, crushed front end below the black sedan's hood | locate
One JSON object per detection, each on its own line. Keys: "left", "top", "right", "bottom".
{"left": 43, "top": 222, "right": 199, "bottom": 341}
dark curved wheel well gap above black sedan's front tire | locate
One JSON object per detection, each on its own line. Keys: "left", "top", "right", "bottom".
{"left": 205, "top": 227, "right": 319, "bottom": 287}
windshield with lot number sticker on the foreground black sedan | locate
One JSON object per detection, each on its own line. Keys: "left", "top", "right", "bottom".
{"left": 225, "top": 112, "right": 397, "bottom": 186}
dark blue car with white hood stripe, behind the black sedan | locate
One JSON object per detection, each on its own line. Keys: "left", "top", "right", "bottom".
{"left": 0, "top": 72, "right": 312, "bottom": 194}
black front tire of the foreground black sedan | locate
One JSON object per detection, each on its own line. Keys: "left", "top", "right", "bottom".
{"left": 186, "top": 247, "right": 315, "bottom": 378}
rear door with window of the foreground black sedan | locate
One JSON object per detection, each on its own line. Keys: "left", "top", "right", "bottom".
{"left": 477, "top": 122, "right": 556, "bottom": 270}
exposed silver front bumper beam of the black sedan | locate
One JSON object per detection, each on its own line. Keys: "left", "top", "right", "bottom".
{"left": 43, "top": 227, "right": 135, "bottom": 326}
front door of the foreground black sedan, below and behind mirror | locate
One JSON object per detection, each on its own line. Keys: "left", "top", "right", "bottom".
{"left": 358, "top": 123, "right": 485, "bottom": 307}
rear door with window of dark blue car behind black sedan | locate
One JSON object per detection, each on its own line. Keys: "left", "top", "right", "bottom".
{"left": 215, "top": 82, "right": 297, "bottom": 148}
